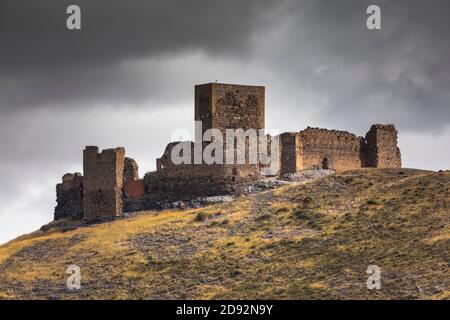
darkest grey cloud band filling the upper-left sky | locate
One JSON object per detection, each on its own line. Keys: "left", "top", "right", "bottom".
{"left": 0, "top": 0, "right": 278, "bottom": 73}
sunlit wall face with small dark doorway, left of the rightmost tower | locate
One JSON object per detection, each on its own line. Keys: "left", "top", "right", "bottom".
{"left": 300, "top": 127, "right": 365, "bottom": 171}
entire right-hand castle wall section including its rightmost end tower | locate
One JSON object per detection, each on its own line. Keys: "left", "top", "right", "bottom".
{"left": 279, "top": 124, "right": 402, "bottom": 174}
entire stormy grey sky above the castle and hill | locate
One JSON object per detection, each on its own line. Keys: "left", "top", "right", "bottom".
{"left": 0, "top": 0, "right": 450, "bottom": 243}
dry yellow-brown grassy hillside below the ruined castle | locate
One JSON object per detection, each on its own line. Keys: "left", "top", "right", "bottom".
{"left": 0, "top": 169, "right": 450, "bottom": 299}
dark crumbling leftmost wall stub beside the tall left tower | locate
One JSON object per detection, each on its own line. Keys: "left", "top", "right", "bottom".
{"left": 54, "top": 172, "right": 84, "bottom": 220}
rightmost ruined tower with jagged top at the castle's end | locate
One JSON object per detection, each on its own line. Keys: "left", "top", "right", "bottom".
{"left": 365, "top": 124, "right": 402, "bottom": 168}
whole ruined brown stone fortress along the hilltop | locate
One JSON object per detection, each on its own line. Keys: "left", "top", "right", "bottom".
{"left": 55, "top": 83, "right": 401, "bottom": 222}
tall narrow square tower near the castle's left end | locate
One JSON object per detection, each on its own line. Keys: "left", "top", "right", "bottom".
{"left": 83, "top": 147, "right": 125, "bottom": 221}
